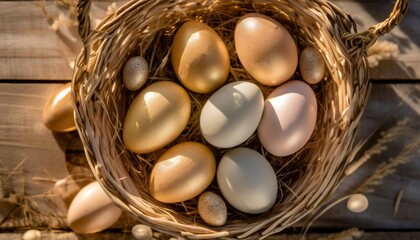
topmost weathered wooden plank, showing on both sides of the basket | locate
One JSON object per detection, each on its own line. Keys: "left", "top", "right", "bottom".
{"left": 0, "top": 0, "right": 420, "bottom": 80}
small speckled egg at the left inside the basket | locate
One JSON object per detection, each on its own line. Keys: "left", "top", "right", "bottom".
{"left": 123, "top": 56, "right": 149, "bottom": 91}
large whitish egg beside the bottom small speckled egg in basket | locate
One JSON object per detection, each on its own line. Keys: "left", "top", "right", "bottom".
{"left": 217, "top": 148, "right": 278, "bottom": 214}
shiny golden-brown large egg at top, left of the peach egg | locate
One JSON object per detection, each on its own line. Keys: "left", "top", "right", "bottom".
{"left": 171, "top": 20, "right": 230, "bottom": 93}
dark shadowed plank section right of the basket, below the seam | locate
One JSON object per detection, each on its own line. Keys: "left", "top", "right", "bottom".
{"left": 315, "top": 84, "right": 420, "bottom": 230}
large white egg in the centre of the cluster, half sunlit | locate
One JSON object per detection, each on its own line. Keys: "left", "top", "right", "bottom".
{"left": 200, "top": 81, "right": 264, "bottom": 148}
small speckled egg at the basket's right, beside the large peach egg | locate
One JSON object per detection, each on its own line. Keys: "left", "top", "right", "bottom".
{"left": 299, "top": 47, "right": 325, "bottom": 84}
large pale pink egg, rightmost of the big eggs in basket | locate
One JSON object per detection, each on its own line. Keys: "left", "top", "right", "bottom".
{"left": 258, "top": 80, "right": 317, "bottom": 156}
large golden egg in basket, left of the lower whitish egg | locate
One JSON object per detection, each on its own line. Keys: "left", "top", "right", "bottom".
{"left": 149, "top": 142, "right": 216, "bottom": 203}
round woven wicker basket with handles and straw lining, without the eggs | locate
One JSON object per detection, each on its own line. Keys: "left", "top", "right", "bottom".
{"left": 72, "top": 0, "right": 408, "bottom": 239}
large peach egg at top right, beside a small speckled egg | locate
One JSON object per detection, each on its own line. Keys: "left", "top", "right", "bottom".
{"left": 235, "top": 13, "right": 298, "bottom": 86}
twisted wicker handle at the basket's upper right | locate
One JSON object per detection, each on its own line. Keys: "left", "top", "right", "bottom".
{"left": 343, "top": 0, "right": 409, "bottom": 49}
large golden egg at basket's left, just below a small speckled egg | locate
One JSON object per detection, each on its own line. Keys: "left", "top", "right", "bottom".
{"left": 123, "top": 81, "right": 191, "bottom": 153}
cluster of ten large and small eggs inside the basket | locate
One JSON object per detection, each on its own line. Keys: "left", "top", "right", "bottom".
{"left": 122, "top": 13, "right": 325, "bottom": 226}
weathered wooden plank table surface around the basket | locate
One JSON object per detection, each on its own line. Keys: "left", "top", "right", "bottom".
{"left": 0, "top": 0, "right": 420, "bottom": 239}
